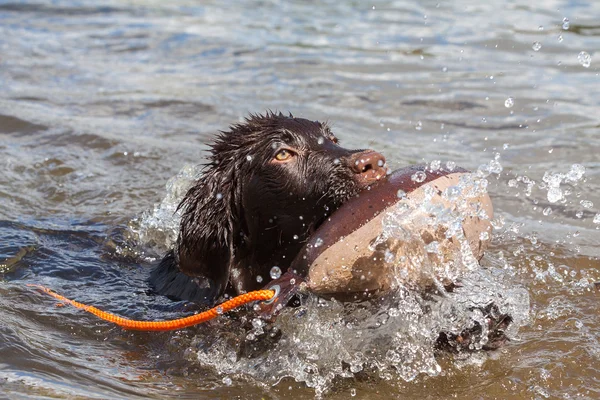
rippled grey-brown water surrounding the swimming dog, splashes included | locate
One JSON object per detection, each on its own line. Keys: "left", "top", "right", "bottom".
{"left": 0, "top": 0, "right": 600, "bottom": 399}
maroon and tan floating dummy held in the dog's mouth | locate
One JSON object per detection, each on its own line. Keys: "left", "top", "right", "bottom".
{"left": 290, "top": 166, "right": 493, "bottom": 297}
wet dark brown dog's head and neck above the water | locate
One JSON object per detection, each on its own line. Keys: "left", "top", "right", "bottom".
{"left": 150, "top": 113, "right": 386, "bottom": 305}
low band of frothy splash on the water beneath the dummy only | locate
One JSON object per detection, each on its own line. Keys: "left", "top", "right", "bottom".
{"left": 189, "top": 269, "right": 529, "bottom": 396}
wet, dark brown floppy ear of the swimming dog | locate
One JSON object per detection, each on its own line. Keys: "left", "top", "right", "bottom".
{"left": 175, "top": 160, "right": 239, "bottom": 297}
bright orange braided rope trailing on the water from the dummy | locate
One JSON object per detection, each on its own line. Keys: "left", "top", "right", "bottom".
{"left": 27, "top": 284, "right": 275, "bottom": 331}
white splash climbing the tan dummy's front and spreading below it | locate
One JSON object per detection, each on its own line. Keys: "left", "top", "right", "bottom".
{"left": 184, "top": 170, "right": 529, "bottom": 397}
